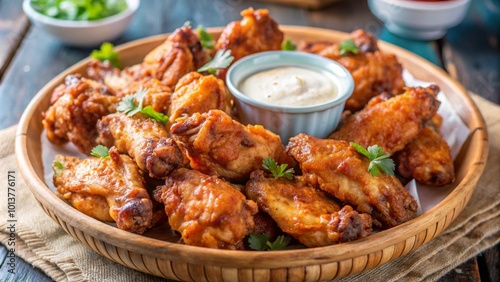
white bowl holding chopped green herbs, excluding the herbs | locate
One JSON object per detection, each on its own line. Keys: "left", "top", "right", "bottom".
{"left": 23, "top": 0, "right": 140, "bottom": 47}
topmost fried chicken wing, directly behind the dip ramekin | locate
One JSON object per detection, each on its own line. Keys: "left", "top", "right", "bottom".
{"left": 215, "top": 8, "right": 284, "bottom": 78}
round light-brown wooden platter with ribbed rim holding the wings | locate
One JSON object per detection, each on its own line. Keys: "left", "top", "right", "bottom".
{"left": 16, "top": 26, "right": 488, "bottom": 281}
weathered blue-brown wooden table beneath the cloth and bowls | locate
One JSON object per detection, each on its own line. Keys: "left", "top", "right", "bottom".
{"left": 0, "top": 0, "right": 500, "bottom": 281}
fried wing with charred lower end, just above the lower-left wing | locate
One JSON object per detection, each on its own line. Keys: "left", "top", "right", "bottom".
{"left": 97, "top": 113, "right": 183, "bottom": 178}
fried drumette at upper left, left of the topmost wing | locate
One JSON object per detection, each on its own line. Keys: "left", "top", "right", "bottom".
{"left": 87, "top": 26, "right": 210, "bottom": 91}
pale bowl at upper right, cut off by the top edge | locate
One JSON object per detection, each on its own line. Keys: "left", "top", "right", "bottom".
{"left": 368, "top": 0, "right": 470, "bottom": 40}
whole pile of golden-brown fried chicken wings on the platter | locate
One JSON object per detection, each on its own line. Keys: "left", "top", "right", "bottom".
{"left": 43, "top": 8, "right": 454, "bottom": 249}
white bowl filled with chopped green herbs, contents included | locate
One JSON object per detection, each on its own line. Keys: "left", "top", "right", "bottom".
{"left": 23, "top": 0, "right": 140, "bottom": 47}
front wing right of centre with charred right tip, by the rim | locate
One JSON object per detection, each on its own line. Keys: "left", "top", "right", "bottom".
{"left": 245, "top": 170, "right": 372, "bottom": 247}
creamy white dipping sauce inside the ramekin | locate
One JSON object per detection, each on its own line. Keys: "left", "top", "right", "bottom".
{"left": 239, "top": 67, "right": 337, "bottom": 107}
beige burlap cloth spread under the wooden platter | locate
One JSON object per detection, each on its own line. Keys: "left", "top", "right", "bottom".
{"left": 0, "top": 95, "right": 500, "bottom": 282}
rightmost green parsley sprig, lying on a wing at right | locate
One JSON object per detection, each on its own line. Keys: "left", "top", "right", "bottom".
{"left": 349, "top": 142, "right": 395, "bottom": 176}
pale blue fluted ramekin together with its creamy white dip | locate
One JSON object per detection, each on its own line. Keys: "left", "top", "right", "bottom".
{"left": 226, "top": 51, "right": 354, "bottom": 144}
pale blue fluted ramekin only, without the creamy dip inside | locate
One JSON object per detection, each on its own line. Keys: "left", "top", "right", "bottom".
{"left": 226, "top": 51, "right": 354, "bottom": 144}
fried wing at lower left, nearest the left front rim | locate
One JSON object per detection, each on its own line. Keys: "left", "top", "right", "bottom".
{"left": 53, "top": 148, "right": 153, "bottom": 234}
